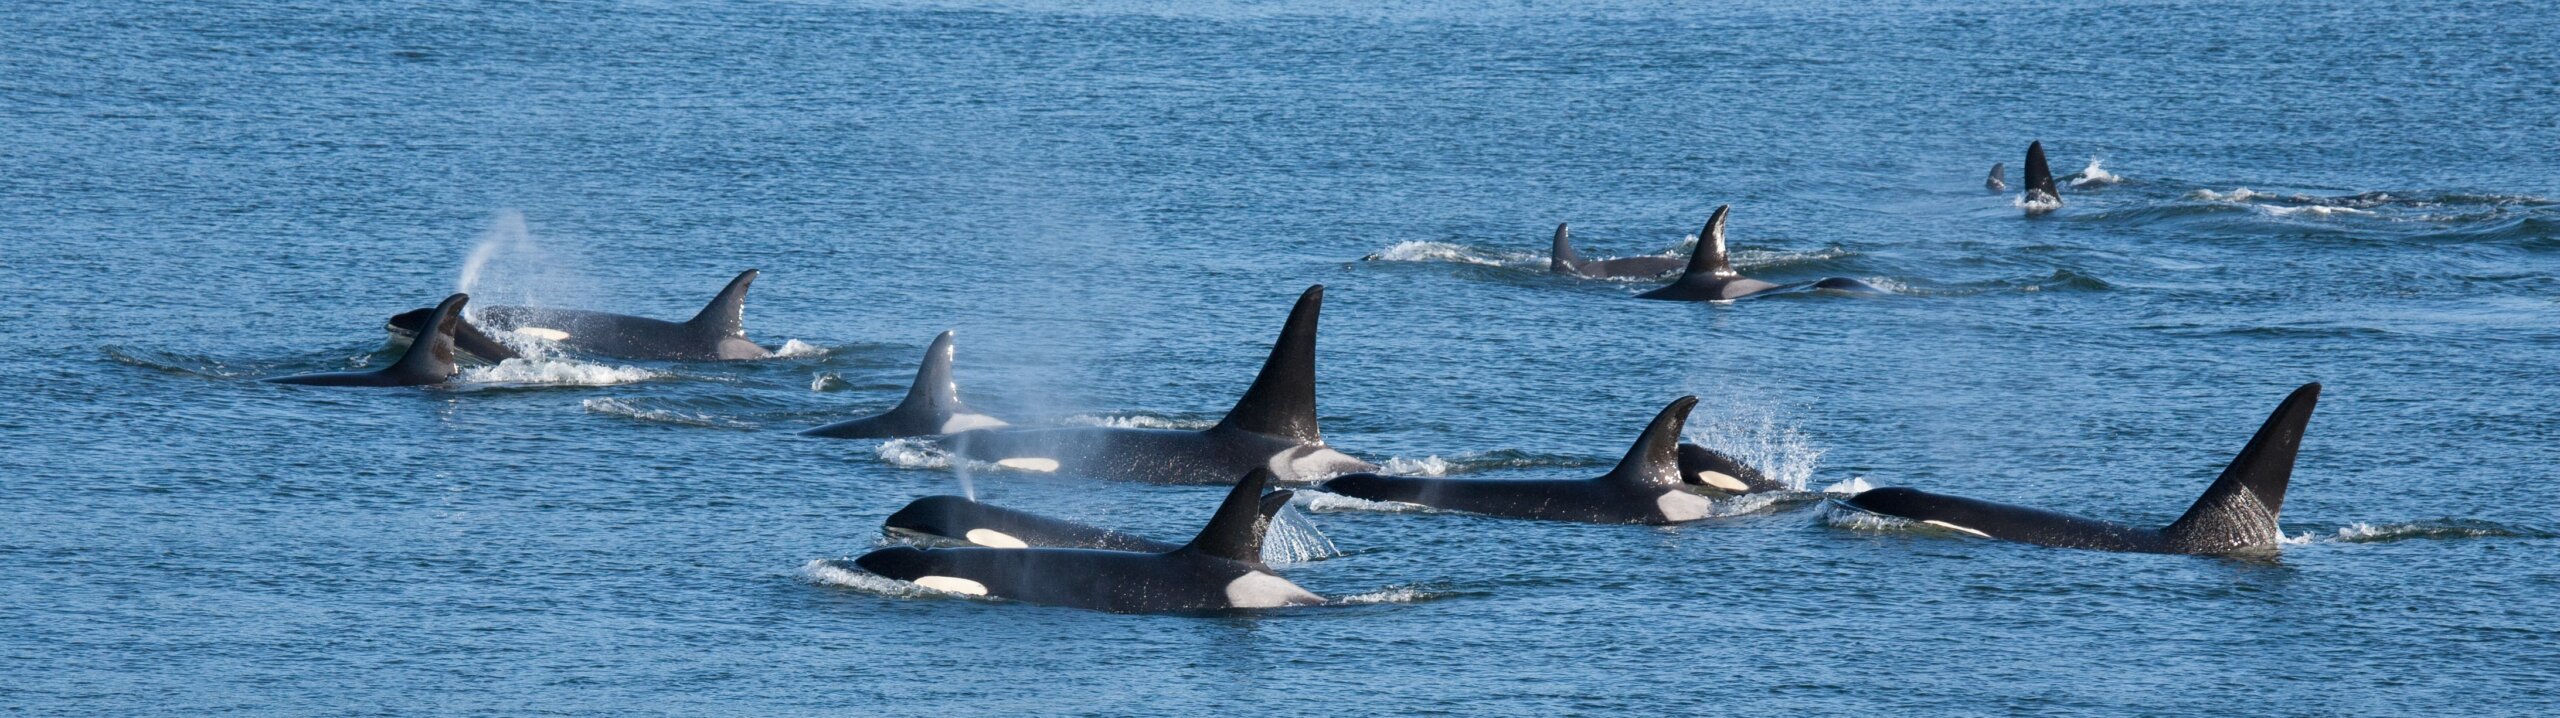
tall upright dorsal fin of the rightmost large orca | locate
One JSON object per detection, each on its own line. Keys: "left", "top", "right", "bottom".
{"left": 2161, "top": 382, "right": 2319, "bottom": 554}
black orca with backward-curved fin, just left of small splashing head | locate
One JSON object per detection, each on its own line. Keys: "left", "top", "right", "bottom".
{"left": 1321, "top": 397, "right": 1715, "bottom": 523}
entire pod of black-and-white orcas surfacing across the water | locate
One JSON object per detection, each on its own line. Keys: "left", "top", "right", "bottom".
{"left": 266, "top": 141, "right": 2319, "bottom": 613}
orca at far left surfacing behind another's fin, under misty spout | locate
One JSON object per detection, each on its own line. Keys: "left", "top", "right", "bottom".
{"left": 392, "top": 269, "right": 773, "bottom": 362}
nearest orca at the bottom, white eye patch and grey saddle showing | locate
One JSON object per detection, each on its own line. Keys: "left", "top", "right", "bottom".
{"left": 852, "top": 469, "right": 1324, "bottom": 613}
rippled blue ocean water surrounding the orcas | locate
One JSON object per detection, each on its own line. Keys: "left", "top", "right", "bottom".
{"left": 0, "top": 0, "right": 2560, "bottom": 715}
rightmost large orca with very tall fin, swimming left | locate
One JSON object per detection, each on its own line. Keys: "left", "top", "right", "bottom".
{"left": 1836, "top": 382, "right": 2319, "bottom": 554}
